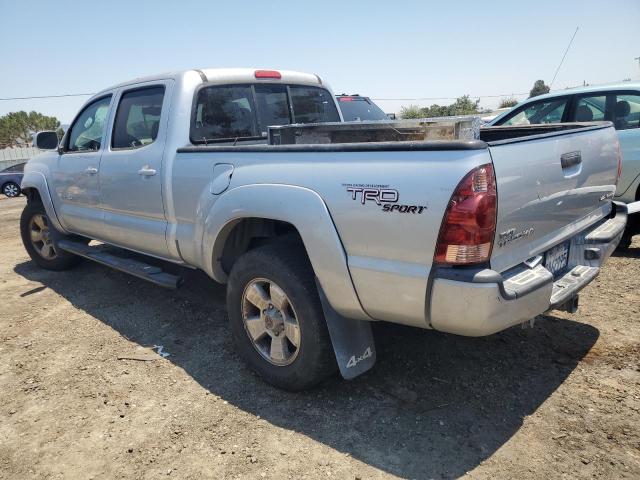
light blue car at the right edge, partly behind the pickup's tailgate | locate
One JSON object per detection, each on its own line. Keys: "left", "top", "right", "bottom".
{"left": 489, "top": 82, "right": 640, "bottom": 247}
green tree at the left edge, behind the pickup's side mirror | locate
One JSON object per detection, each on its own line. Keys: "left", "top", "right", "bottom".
{"left": 0, "top": 111, "right": 64, "bottom": 148}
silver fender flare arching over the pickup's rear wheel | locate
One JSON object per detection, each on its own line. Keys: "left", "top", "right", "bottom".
{"left": 201, "top": 184, "right": 371, "bottom": 320}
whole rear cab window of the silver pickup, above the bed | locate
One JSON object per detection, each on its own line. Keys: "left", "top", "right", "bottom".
{"left": 191, "top": 83, "right": 340, "bottom": 143}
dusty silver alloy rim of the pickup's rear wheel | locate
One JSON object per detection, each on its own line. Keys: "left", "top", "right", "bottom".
{"left": 241, "top": 278, "right": 300, "bottom": 366}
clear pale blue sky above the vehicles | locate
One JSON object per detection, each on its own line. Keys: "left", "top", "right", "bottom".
{"left": 0, "top": 0, "right": 640, "bottom": 124}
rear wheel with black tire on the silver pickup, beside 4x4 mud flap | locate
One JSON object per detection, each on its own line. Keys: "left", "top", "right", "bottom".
{"left": 227, "top": 242, "right": 337, "bottom": 391}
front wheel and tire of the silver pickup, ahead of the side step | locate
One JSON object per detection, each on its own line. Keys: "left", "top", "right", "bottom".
{"left": 20, "top": 202, "right": 86, "bottom": 271}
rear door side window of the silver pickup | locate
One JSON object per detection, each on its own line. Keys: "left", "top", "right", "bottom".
{"left": 111, "top": 87, "right": 164, "bottom": 148}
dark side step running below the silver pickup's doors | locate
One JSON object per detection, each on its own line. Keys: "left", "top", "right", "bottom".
{"left": 58, "top": 240, "right": 182, "bottom": 288}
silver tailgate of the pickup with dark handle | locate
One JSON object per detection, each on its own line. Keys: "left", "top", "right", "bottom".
{"left": 489, "top": 124, "right": 618, "bottom": 272}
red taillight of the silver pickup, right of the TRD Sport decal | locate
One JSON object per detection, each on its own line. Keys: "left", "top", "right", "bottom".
{"left": 435, "top": 163, "right": 497, "bottom": 265}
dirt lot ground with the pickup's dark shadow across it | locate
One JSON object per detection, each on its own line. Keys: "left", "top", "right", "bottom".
{"left": 0, "top": 198, "right": 640, "bottom": 480}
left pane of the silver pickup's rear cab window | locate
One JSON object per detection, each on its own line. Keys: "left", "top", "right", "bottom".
{"left": 191, "top": 85, "right": 258, "bottom": 143}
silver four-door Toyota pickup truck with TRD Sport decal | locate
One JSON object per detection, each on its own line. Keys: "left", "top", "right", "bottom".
{"left": 20, "top": 69, "right": 627, "bottom": 390}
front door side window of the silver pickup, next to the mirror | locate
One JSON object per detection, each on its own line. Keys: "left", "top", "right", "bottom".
{"left": 66, "top": 95, "right": 111, "bottom": 152}
